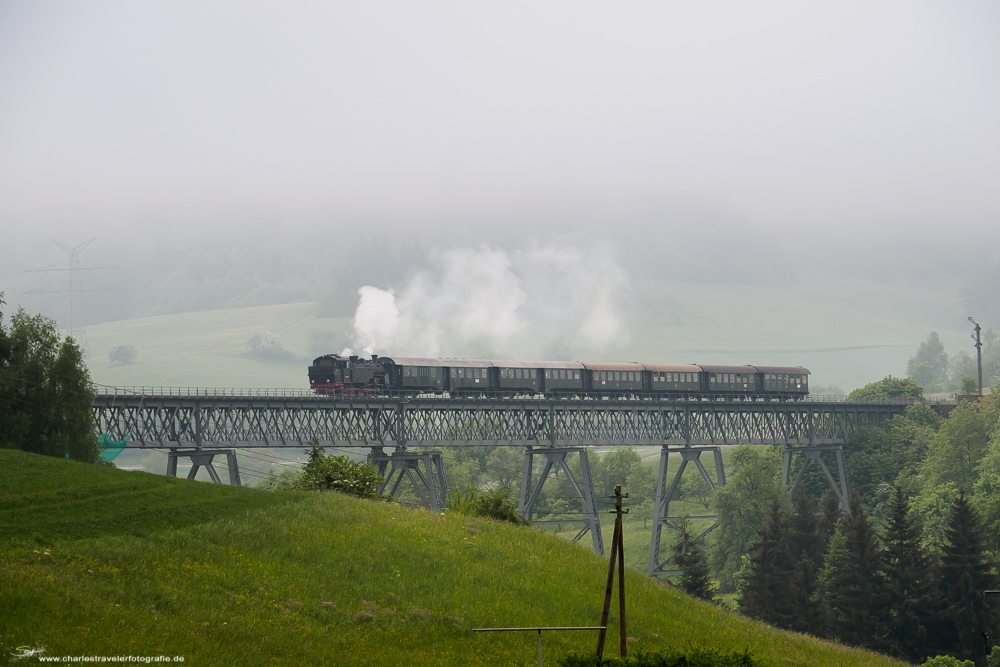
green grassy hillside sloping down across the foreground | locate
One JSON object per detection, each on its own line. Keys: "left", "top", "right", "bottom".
{"left": 0, "top": 451, "right": 899, "bottom": 666}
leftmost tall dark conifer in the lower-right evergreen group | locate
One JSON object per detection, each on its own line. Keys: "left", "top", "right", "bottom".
{"left": 739, "top": 498, "right": 792, "bottom": 628}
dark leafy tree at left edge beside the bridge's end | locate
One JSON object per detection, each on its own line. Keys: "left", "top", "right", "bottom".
{"left": 0, "top": 294, "right": 99, "bottom": 463}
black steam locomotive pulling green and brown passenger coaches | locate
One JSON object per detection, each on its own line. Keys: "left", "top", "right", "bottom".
{"left": 309, "top": 354, "right": 810, "bottom": 400}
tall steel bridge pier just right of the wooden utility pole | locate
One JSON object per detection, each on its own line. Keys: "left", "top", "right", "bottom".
{"left": 647, "top": 445, "right": 726, "bottom": 577}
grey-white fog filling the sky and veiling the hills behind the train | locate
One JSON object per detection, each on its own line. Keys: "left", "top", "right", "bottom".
{"left": 0, "top": 0, "right": 1000, "bottom": 382}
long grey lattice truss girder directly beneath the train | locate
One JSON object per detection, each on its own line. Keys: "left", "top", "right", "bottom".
{"left": 94, "top": 395, "right": 904, "bottom": 447}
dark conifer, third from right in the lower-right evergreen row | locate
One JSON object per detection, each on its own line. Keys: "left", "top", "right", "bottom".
{"left": 833, "top": 492, "right": 885, "bottom": 649}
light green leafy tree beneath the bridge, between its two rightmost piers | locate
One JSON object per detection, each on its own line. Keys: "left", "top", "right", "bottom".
{"left": 711, "top": 445, "right": 789, "bottom": 579}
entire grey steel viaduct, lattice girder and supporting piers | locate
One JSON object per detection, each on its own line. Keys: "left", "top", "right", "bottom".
{"left": 94, "top": 388, "right": 906, "bottom": 576}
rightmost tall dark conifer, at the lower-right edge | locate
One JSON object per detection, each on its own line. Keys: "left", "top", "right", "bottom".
{"left": 939, "top": 489, "right": 997, "bottom": 660}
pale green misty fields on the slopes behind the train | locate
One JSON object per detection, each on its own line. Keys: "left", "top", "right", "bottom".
{"left": 78, "top": 278, "right": 969, "bottom": 391}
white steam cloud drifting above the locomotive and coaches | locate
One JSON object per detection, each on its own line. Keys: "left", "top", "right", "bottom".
{"left": 344, "top": 245, "right": 628, "bottom": 357}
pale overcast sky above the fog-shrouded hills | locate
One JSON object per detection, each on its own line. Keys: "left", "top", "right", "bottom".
{"left": 0, "top": 0, "right": 1000, "bottom": 243}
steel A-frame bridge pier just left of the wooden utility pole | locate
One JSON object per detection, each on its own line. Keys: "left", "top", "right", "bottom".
{"left": 518, "top": 446, "right": 604, "bottom": 556}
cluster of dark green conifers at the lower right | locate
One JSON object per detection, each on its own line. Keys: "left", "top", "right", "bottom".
{"left": 737, "top": 486, "right": 997, "bottom": 662}
